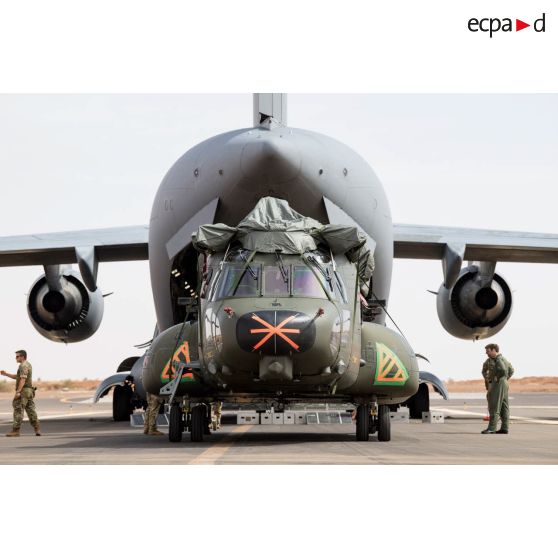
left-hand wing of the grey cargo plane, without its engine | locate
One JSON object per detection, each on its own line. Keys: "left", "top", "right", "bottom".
{"left": 0, "top": 225, "right": 149, "bottom": 267}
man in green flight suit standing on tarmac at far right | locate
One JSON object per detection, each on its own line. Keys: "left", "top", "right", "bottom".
{"left": 482, "top": 343, "right": 514, "bottom": 434}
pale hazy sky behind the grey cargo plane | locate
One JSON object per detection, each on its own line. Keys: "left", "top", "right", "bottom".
{"left": 0, "top": 94, "right": 558, "bottom": 380}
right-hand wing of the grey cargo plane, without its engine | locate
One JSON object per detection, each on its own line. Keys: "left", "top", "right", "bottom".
{"left": 393, "top": 224, "right": 558, "bottom": 263}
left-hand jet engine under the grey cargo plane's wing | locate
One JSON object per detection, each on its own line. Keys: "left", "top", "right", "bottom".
{"left": 27, "top": 270, "right": 104, "bottom": 343}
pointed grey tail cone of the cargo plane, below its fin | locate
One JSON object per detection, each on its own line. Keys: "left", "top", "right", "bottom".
{"left": 240, "top": 132, "right": 301, "bottom": 183}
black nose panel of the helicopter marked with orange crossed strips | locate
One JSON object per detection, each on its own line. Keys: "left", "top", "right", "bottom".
{"left": 236, "top": 310, "right": 316, "bottom": 355}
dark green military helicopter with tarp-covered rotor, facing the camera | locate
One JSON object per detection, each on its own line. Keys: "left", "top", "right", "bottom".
{"left": 143, "top": 197, "right": 428, "bottom": 442}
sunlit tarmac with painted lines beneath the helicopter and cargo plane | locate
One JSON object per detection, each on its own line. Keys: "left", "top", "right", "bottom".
{"left": 0, "top": 392, "right": 558, "bottom": 465}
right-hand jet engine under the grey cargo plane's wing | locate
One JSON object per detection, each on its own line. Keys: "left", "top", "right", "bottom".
{"left": 436, "top": 265, "right": 512, "bottom": 340}
